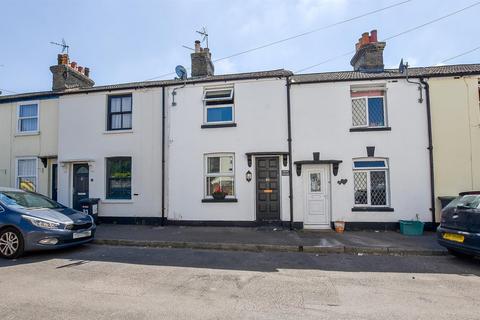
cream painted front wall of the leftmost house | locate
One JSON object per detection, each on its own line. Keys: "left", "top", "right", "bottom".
{"left": 0, "top": 98, "right": 58, "bottom": 196}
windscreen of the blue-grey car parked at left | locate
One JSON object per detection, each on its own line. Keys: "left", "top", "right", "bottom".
{"left": 0, "top": 191, "right": 63, "bottom": 209}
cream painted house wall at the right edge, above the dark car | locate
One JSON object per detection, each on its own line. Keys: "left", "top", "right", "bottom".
{"left": 428, "top": 76, "right": 480, "bottom": 221}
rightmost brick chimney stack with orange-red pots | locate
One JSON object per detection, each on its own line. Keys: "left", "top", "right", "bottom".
{"left": 350, "top": 30, "right": 386, "bottom": 72}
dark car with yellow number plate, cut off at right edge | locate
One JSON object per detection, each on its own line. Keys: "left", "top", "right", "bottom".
{"left": 437, "top": 191, "right": 480, "bottom": 256}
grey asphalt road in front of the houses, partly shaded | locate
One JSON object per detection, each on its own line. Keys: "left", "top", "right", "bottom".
{"left": 0, "top": 245, "right": 480, "bottom": 320}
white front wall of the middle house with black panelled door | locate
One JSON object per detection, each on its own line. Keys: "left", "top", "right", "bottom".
{"left": 167, "top": 79, "right": 290, "bottom": 221}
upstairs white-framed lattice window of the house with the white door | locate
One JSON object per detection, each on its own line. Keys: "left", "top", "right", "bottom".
{"left": 350, "top": 88, "right": 387, "bottom": 128}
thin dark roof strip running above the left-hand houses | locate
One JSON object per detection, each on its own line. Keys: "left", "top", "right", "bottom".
{"left": 0, "top": 69, "right": 293, "bottom": 103}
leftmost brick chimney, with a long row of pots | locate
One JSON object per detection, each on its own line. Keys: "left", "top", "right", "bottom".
{"left": 50, "top": 53, "right": 95, "bottom": 91}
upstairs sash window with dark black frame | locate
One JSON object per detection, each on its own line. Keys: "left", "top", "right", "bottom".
{"left": 107, "top": 94, "right": 132, "bottom": 130}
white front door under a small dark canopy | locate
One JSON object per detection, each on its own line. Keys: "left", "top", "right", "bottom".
{"left": 304, "top": 165, "right": 331, "bottom": 229}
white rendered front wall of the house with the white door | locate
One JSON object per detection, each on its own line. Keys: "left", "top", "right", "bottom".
{"left": 292, "top": 80, "right": 431, "bottom": 222}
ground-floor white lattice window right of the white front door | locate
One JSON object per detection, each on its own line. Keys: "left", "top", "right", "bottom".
{"left": 353, "top": 158, "right": 390, "bottom": 207}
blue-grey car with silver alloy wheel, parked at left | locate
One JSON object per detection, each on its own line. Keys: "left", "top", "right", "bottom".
{"left": 0, "top": 187, "right": 96, "bottom": 259}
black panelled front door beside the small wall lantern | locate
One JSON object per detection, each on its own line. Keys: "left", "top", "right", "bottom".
{"left": 255, "top": 157, "right": 280, "bottom": 222}
